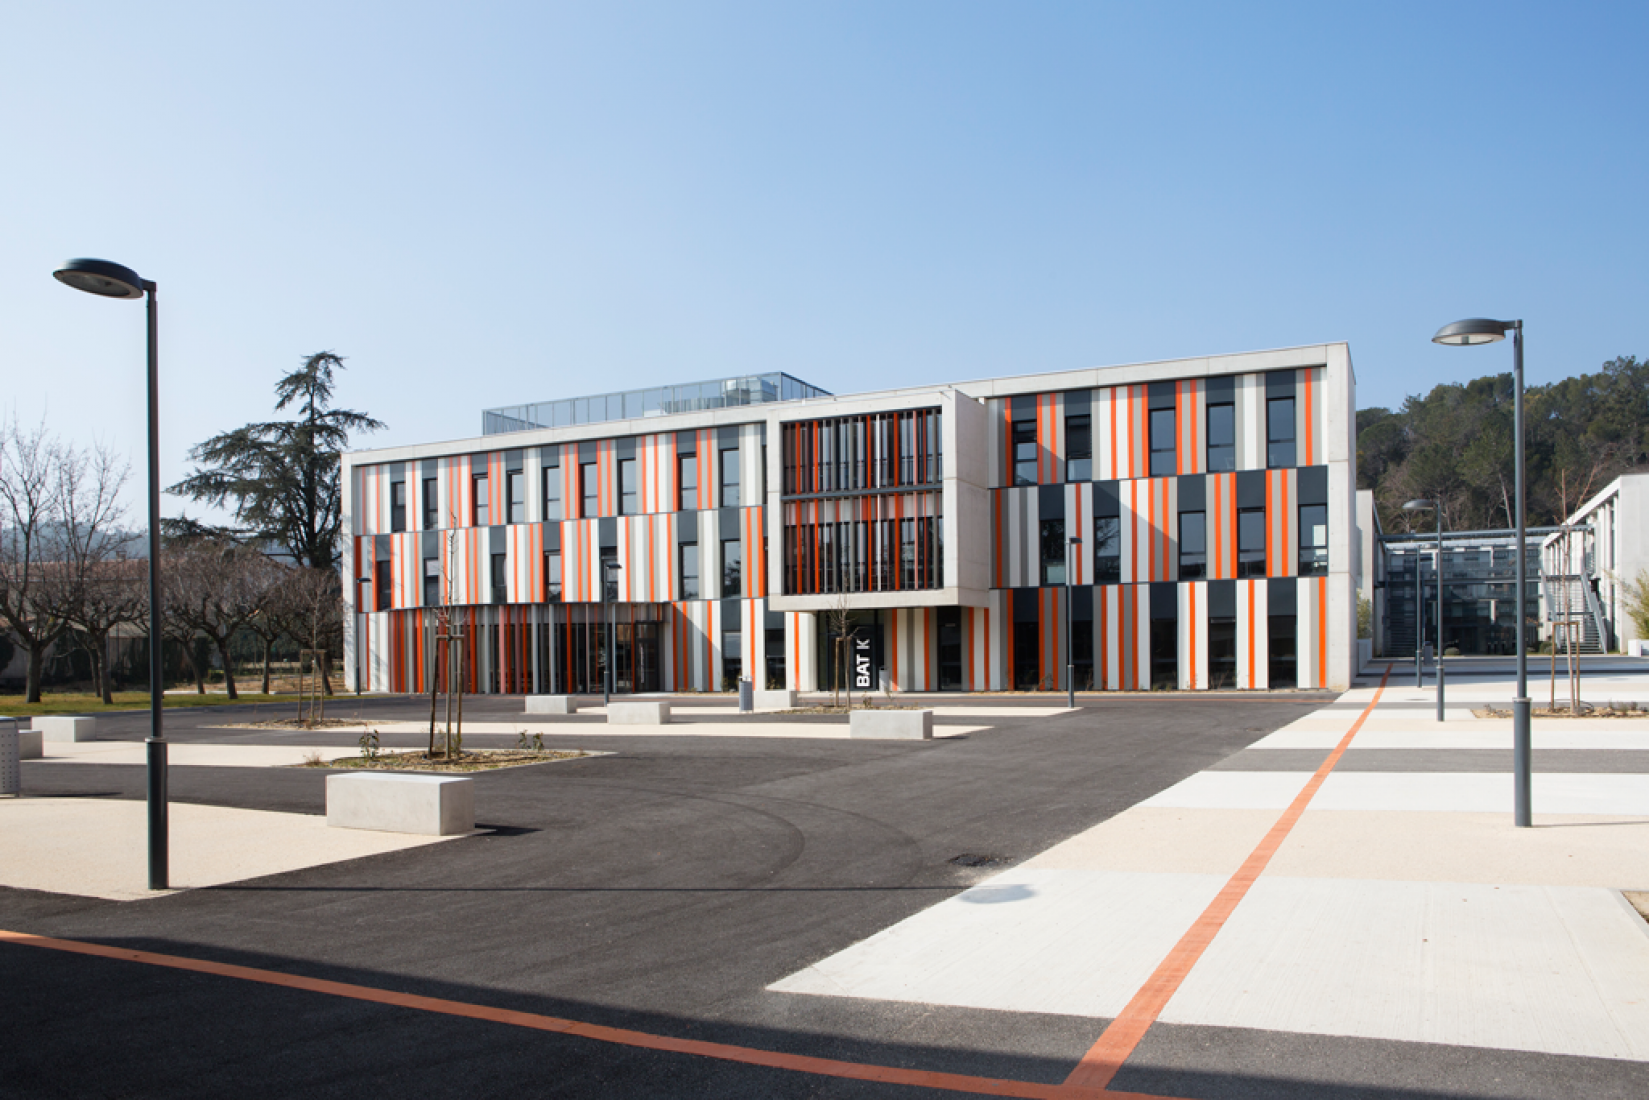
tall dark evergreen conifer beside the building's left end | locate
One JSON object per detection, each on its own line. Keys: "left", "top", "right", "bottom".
{"left": 167, "top": 351, "right": 384, "bottom": 567}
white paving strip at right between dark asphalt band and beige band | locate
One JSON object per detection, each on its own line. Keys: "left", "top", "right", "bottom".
{"left": 1141, "top": 772, "right": 1649, "bottom": 815}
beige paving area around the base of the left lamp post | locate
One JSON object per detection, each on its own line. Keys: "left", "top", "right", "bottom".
{"left": 0, "top": 798, "right": 453, "bottom": 900}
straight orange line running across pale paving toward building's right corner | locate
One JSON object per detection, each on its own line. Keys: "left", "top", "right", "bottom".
{"left": 1065, "top": 665, "right": 1392, "bottom": 1088}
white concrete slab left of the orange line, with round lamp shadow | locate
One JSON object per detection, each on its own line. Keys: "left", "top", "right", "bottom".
{"left": 768, "top": 867, "right": 1225, "bottom": 1018}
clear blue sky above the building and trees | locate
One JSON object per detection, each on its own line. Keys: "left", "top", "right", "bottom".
{"left": 0, "top": 0, "right": 1649, "bottom": 511}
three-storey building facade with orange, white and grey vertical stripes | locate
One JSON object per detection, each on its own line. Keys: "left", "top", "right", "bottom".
{"left": 345, "top": 345, "right": 1355, "bottom": 693}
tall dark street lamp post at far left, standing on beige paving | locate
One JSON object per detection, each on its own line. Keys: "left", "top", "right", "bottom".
{"left": 51, "top": 259, "right": 170, "bottom": 891}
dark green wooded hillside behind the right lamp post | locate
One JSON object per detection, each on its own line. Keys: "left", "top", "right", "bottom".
{"left": 1357, "top": 356, "right": 1649, "bottom": 534}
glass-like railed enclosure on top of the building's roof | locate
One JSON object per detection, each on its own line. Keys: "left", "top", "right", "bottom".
{"left": 482, "top": 371, "right": 831, "bottom": 435}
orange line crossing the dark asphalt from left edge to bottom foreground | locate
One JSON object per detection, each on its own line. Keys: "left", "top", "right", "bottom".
{"left": 0, "top": 930, "right": 1172, "bottom": 1100}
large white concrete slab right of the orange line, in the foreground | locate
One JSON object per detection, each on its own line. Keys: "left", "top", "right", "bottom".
{"left": 1161, "top": 876, "right": 1649, "bottom": 1060}
